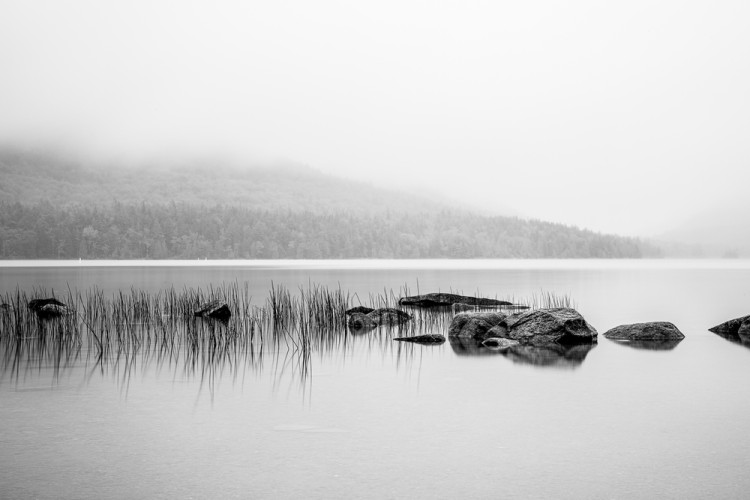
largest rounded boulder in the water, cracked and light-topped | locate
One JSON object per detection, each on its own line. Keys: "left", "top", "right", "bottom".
{"left": 487, "top": 307, "right": 598, "bottom": 345}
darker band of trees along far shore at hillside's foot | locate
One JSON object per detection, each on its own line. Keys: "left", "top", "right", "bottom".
{"left": 0, "top": 202, "right": 658, "bottom": 259}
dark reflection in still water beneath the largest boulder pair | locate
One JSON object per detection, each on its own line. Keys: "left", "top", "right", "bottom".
{"left": 448, "top": 337, "right": 596, "bottom": 368}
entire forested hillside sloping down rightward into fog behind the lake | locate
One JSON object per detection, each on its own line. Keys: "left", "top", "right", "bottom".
{"left": 0, "top": 147, "right": 657, "bottom": 259}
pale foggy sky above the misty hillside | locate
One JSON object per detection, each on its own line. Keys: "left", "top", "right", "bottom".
{"left": 0, "top": 0, "right": 750, "bottom": 234}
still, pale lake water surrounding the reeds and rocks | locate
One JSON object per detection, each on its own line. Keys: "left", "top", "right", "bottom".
{"left": 0, "top": 260, "right": 750, "bottom": 499}
